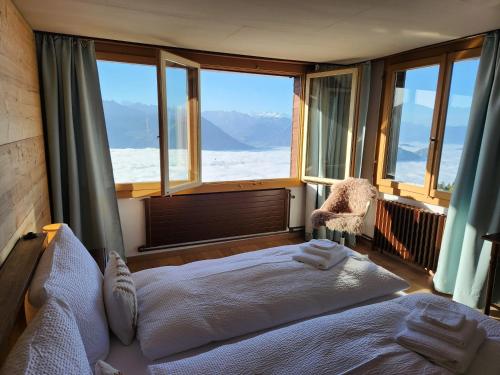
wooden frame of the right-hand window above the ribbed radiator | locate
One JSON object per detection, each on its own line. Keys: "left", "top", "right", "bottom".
{"left": 375, "top": 44, "right": 482, "bottom": 207}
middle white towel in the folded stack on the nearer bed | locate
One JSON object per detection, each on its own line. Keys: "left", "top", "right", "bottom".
{"left": 406, "top": 309, "right": 477, "bottom": 348}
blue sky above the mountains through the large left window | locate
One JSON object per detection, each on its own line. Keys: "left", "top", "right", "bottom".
{"left": 98, "top": 61, "right": 293, "bottom": 116}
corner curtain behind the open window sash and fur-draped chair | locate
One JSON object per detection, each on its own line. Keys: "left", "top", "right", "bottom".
{"left": 305, "top": 63, "right": 371, "bottom": 246}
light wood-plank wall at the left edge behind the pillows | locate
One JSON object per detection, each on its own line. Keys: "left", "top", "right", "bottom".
{"left": 0, "top": 0, "right": 50, "bottom": 264}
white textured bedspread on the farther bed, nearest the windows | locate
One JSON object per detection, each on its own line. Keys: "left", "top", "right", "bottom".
{"left": 133, "top": 245, "right": 408, "bottom": 359}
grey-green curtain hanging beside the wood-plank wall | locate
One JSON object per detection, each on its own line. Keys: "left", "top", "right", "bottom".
{"left": 35, "top": 33, "right": 124, "bottom": 256}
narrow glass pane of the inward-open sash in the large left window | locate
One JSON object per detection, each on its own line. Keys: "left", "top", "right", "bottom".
{"left": 165, "top": 66, "right": 190, "bottom": 181}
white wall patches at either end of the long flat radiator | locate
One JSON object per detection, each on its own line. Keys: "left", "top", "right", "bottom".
{"left": 118, "top": 187, "right": 305, "bottom": 256}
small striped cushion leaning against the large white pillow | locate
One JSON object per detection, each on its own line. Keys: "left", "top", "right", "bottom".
{"left": 104, "top": 251, "right": 137, "bottom": 345}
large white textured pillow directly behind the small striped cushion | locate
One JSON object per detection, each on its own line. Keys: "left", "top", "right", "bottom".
{"left": 28, "top": 225, "right": 109, "bottom": 366}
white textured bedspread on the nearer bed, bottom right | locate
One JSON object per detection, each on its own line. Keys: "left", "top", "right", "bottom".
{"left": 149, "top": 294, "right": 500, "bottom": 375}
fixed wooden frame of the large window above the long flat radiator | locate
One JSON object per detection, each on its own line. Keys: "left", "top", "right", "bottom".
{"left": 95, "top": 40, "right": 304, "bottom": 198}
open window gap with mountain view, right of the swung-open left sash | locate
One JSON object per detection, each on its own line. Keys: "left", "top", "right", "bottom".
{"left": 201, "top": 70, "right": 293, "bottom": 182}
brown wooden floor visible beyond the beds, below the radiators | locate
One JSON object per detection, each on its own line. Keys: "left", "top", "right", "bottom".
{"left": 127, "top": 232, "right": 500, "bottom": 319}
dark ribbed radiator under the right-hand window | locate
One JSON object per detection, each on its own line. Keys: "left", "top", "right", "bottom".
{"left": 373, "top": 200, "right": 446, "bottom": 272}
